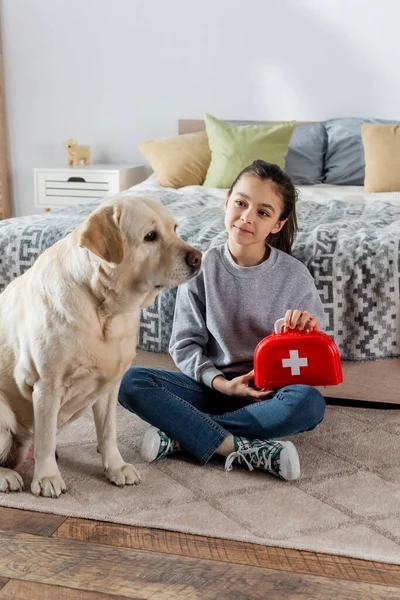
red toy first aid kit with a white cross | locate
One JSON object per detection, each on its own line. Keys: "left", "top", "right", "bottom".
{"left": 254, "top": 319, "right": 343, "bottom": 389}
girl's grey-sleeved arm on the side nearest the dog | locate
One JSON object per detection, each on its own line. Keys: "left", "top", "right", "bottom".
{"left": 169, "top": 273, "right": 223, "bottom": 387}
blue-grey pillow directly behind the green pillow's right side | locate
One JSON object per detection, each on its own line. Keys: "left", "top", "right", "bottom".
{"left": 233, "top": 121, "right": 327, "bottom": 185}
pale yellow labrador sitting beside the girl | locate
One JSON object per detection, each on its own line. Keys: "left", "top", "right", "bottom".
{"left": 0, "top": 196, "right": 201, "bottom": 497}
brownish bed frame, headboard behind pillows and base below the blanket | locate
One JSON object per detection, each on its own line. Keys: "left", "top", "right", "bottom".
{"left": 178, "top": 119, "right": 400, "bottom": 404}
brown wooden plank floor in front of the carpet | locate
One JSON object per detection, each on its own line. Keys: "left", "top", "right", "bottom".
{"left": 0, "top": 500, "right": 400, "bottom": 600}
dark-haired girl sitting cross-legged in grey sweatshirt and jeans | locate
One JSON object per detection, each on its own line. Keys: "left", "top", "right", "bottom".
{"left": 119, "top": 160, "right": 325, "bottom": 480}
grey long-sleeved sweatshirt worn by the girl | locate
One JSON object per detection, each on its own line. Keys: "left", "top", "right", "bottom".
{"left": 169, "top": 244, "right": 325, "bottom": 387}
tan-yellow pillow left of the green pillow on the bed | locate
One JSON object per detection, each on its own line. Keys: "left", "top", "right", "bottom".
{"left": 138, "top": 131, "right": 211, "bottom": 188}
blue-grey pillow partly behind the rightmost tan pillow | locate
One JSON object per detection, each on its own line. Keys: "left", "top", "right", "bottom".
{"left": 323, "top": 117, "right": 399, "bottom": 185}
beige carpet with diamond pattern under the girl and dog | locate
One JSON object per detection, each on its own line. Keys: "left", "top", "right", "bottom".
{"left": 0, "top": 355, "right": 400, "bottom": 564}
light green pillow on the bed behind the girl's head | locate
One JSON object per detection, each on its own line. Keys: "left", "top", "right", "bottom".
{"left": 203, "top": 115, "right": 296, "bottom": 188}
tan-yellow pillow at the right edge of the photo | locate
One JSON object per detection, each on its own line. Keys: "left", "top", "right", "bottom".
{"left": 361, "top": 123, "right": 400, "bottom": 192}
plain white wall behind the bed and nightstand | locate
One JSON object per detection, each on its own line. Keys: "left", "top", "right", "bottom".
{"left": 2, "top": 0, "right": 400, "bottom": 215}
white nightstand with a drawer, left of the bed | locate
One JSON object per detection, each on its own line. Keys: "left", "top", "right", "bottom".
{"left": 33, "top": 164, "right": 148, "bottom": 210}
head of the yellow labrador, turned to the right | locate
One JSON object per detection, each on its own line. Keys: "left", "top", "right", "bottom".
{"left": 78, "top": 196, "right": 201, "bottom": 292}
